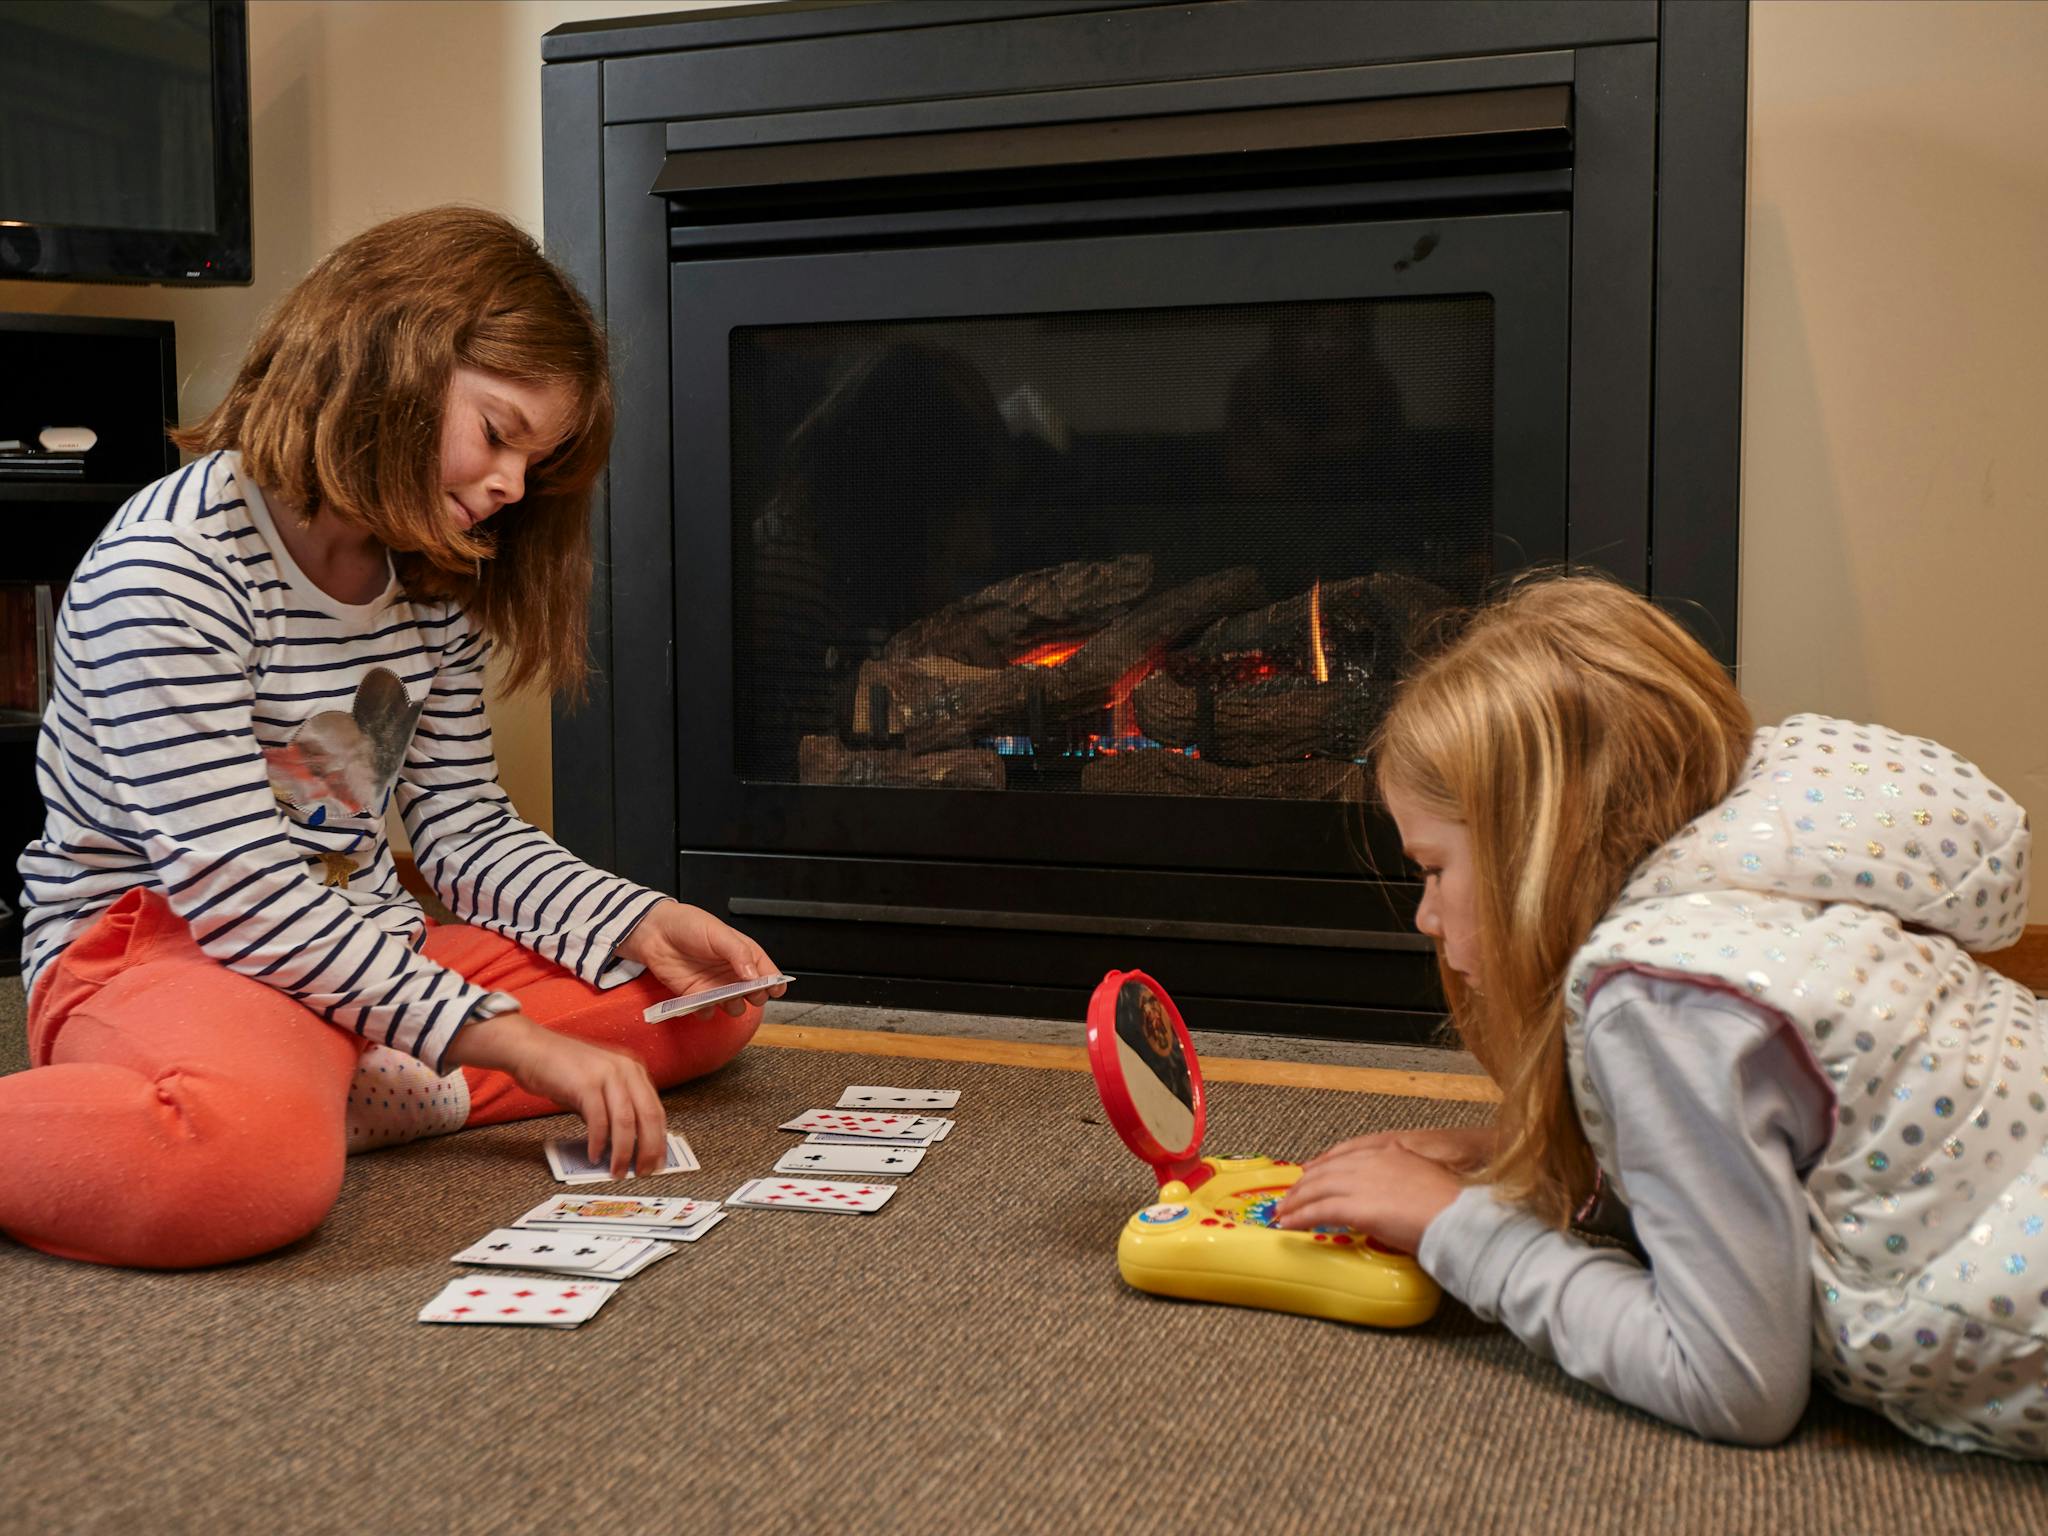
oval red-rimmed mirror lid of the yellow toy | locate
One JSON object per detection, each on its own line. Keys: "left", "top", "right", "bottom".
{"left": 1087, "top": 971, "right": 1212, "bottom": 1190}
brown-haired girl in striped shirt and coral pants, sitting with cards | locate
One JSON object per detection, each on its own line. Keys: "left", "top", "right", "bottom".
{"left": 0, "top": 209, "right": 780, "bottom": 1268}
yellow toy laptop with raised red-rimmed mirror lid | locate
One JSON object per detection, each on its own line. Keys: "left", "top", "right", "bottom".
{"left": 1087, "top": 971, "right": 1438, "bottom": 1327}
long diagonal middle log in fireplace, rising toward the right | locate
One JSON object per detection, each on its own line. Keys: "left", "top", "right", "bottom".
{"left": 903, "top": 565, "right": 1264, "bottom": 752}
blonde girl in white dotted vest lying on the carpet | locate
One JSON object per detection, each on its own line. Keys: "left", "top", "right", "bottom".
{"left": 1280, "top": 578, "right": 2048, "bottom": 1458}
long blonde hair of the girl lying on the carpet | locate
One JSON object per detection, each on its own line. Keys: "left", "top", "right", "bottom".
{"left": 1374, "top": 573, "right": 1753, "bottom": 1227}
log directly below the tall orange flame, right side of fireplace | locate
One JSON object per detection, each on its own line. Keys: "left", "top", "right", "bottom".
{"left": 1130, "top": 672, "right": 1384, "bottom": 764}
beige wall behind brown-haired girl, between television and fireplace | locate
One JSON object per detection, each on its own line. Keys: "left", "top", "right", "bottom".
{"left": 0, "top": 0, "right": 737, "bottom": 843}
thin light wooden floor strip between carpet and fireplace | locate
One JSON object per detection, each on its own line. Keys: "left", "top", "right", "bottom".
{"left": 754, "top": 1024, "right": 1499, "bottom": 1104}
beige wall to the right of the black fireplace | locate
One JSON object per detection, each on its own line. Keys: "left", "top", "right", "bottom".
{"left": 1741, "top": 0, "right": 2048, "bottom": 922}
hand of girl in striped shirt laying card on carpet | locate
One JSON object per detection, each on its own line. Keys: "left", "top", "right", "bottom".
{"left": 442, "top": 1014, "right": 668, "bottom": 1180}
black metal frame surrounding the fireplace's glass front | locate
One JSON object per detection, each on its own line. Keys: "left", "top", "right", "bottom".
{"left": 543, "top": 0, "right": 1747, "bottom": 1038}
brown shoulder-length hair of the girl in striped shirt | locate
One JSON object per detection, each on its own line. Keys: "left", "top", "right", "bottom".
{"left": 174, "top": 207, "right": 612, "bottom": 694}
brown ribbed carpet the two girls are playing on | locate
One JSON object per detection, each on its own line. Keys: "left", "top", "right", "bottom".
{"left": 0, "top": 1011, "right": 2048, "bottom": 1536}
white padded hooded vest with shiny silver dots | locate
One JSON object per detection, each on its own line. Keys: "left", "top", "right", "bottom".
{"left": 1565, "top": 715, "right": 2048, "bottom": 1458}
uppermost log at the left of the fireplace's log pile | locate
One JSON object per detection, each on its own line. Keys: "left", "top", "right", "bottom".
{"left": 883, "top": 555, "right": 1153, "bottom": 668}
